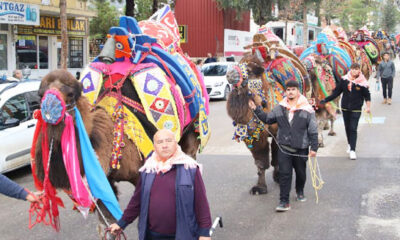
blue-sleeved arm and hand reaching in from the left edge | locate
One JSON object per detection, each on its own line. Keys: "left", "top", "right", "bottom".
{"left": 0, "top": 174, "right": 38, "bottom": 202}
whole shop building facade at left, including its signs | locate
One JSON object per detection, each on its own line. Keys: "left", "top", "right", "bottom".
{"left": 0, "top": 0, "right": 96, "bottom": 78}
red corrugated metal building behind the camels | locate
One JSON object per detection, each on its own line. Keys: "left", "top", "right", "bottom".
{"left": 175, "top": 0, "right": 250, "bottom": 57}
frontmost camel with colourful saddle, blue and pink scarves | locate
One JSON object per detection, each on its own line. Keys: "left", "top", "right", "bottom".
{"left": 32, "top": 6, "right": 210, "bottom": 236}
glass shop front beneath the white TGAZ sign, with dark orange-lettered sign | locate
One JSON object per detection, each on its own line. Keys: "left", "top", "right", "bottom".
{"left": 0, "top": 3, "right": 94, "bottom": 79}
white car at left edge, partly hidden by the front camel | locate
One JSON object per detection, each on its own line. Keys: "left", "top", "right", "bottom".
{"left": 0, "top": 80, "right": 40, "bottom": 173}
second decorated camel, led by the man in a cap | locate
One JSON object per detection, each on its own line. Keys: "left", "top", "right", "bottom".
{"left": 227, "top": 30, "right": 310, "bottom": 194}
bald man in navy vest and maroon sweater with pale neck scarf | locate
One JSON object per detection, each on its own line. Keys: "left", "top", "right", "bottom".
{"left": 110, "top": 129, "right": 212, "bottom": 240}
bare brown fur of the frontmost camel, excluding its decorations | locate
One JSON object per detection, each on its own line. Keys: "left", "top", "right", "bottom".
{"left": 34, "top": 70, "right": 199, "bottom": 237}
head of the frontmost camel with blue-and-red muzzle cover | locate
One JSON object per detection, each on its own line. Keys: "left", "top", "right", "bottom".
{"left": 38, "top": 69, "right": 82, "bottom": 125}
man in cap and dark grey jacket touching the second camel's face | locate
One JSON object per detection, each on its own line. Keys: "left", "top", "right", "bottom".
{"left": 249, "top": 81, "right": 318, "bottom": 212}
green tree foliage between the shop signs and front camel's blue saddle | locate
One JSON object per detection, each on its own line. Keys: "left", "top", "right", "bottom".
{"left": 89, "top": 0, "right": 120, "bottom": 38}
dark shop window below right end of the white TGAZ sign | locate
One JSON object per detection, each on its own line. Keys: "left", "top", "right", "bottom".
{"left": 15, "top": 35, "right": 38, "bottom": 69}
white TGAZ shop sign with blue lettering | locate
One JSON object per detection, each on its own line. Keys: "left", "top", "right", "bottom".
{"left": 0, "top": 1, "right": 40, "bottom": 26}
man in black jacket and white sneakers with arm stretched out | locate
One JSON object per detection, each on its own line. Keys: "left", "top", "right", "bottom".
{"left": 321, "top": 63, "right": 371, "bottom": 160}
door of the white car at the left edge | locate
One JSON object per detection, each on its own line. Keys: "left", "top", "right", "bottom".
{"left": 0, "top": 93, "right": 36, "bottom": 172}
